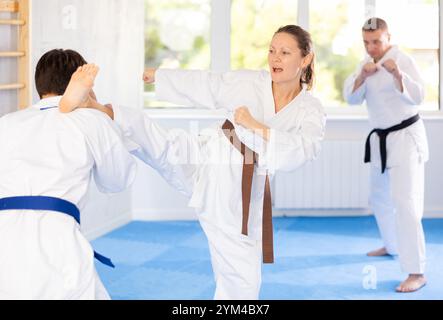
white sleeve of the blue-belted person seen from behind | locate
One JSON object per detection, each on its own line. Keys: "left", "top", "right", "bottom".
{"left": 87, "top": 111, "right": 137, "bottom": 193}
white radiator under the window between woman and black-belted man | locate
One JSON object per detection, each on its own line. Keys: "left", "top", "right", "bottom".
{"left": 273, "top": 140, "right": 369, "bottom": 209}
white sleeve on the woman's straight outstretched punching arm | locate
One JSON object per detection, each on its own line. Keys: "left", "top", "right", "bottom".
{"left": 155, "top": 69, "right": 260, "bottom": 111}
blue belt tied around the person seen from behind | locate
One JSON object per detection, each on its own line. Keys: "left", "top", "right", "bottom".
{"left": 0, "top": 196, "right": 115, "bottom": 268}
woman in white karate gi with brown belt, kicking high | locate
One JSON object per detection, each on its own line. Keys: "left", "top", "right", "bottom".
{"left": 61, "top": 26, "right": 325, "bottom": 299}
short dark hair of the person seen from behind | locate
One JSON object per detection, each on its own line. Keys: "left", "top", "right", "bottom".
{"left": 35, "top": 49, "right": 87, "bottom": 99}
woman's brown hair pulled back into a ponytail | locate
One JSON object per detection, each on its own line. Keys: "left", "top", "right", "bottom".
{"left": 275, "top": 24, "right": 315, "bottom": 90}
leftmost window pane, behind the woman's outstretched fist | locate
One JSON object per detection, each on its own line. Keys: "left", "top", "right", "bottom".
{"left": 145, "top": 0, "right": 211, "bottom": 107}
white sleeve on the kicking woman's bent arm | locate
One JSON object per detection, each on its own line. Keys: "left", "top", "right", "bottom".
{"left": 259, "top": 108, "right": 326, "bottom": 174}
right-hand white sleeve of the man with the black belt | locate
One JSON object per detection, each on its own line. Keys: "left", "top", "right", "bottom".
{"left": 396, "top": 58, "right": 425, "bottom": 105}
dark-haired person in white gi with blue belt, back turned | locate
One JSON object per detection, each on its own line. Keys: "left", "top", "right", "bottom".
{"left": 0, "top": 50, "right": 136, "bottom": 300}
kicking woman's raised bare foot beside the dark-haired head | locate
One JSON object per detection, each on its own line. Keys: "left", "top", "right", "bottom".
{"left": 59, "top": 64, "right": 99, "bottom": 113}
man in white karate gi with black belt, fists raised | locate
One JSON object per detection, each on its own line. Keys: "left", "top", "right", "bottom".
{"left": 344, "top": 18, "right": 429, "bottom": 292}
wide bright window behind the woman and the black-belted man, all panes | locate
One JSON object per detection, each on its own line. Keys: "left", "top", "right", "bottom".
{"left": 145, "top": 0, "right": 440, "bottom": 112}
